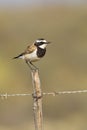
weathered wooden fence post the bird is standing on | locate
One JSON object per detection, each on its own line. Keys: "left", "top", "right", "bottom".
{"left": 31, "top": 69, "right": 43, "bottom": 130}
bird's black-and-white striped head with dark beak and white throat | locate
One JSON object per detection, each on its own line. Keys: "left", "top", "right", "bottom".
{"left": 34, "top": 38, "right": 50, "bottom": 49}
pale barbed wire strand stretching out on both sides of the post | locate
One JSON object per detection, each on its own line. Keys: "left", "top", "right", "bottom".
{"left": 0, "top": 90, "right": 87, "bottom": 99}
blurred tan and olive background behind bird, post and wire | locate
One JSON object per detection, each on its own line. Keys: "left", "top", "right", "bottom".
{"left": 0, "top": 0, "right": 87, "bottom": 130}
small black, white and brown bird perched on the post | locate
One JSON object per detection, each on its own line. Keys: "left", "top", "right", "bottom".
{"left": 13, "top": 38, "right": 51, "bottom": 69}
